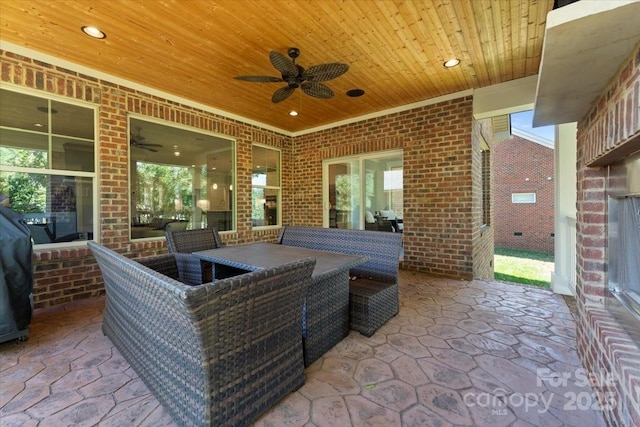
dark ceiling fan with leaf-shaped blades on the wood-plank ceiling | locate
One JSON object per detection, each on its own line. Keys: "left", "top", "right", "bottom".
{"left": 234, "top": 47, "right": 349, "bottom": 103}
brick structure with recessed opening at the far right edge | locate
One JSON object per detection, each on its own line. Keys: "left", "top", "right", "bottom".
{"left": 576, "top": 45, "right": 640, "bottom": 426}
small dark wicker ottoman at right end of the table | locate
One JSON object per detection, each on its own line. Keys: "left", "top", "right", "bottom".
{"left": 349, "top": 278, "right": 398, "bottom": 337}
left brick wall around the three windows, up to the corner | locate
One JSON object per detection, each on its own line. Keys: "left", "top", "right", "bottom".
{"left": 0, "top": 51, "right": 292, "bottom": 308}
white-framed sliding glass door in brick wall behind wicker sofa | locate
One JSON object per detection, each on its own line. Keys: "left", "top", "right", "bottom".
{"left": 322, "top": 150, "right": 403, "bottom": 230}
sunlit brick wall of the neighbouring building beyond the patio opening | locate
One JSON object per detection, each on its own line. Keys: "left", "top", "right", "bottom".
{"left": 493, "top": 135, "right": 554, "bottom": 253}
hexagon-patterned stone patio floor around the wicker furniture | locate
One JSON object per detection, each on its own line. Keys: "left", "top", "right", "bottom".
{"left": 0, "top": 270, "right": 605, "bottom": 427}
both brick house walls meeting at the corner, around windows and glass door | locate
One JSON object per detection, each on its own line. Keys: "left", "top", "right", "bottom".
{"left": 0, "top": 51, "right": 491, "bottom": 308}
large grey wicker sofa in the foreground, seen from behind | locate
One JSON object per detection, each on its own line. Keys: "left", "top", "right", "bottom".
{"left": 88, "top": 242, "right": 315, "bottom": 426}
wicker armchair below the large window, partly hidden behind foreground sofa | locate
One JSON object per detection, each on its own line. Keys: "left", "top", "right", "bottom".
{"left": 166, "top": 228, "right": 225, "bottom": 285}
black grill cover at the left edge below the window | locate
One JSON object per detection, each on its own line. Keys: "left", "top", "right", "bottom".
{"left": 0, "top": 206, "right": 33, "bottom": 342}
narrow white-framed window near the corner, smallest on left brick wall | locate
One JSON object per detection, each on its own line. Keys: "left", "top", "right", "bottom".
{"left": 251, "top": 145, "right": 281, "bottom": 227}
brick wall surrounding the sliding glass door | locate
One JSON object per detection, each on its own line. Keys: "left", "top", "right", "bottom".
{"left": 296, "top": 97, "right": 493, "bottom": 279}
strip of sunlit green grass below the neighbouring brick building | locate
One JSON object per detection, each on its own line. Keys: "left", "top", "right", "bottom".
{"left": 493, "top": 248, "right": 554, "bottom": 288}
